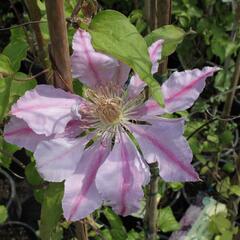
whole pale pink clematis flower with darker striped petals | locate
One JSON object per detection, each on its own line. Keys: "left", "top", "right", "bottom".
{"left": 4, "top": 29, "right": 218, "bottom": 221}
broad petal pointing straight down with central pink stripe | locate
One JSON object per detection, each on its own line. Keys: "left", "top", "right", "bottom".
{"left": 96, "top": 133, "right": 149, "bottom": 216}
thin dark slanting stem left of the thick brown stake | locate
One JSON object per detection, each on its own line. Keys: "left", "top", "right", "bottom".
{"left": 25, "top": 0, "right": 48, "bottom": 69}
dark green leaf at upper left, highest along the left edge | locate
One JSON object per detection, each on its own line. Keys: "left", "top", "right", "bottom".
{"left": 3, "top": 28, "right": 29, "bottom": 72}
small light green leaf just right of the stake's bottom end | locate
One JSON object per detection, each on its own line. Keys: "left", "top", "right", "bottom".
{"left": 158, "top": 207, "right": 180, "bottom": 232}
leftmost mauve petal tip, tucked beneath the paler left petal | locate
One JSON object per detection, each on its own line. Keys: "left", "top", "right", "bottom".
{"left": 4, "top": 116, "right": 50, "bottom": 152}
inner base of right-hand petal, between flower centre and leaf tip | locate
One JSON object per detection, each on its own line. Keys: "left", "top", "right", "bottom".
{"left": 129, "top": 99, "right": 165, "bottom": 120}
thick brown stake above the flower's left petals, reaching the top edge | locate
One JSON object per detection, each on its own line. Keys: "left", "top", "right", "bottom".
{"left": 45, "top": 0, "right": 72, "bottom": 91}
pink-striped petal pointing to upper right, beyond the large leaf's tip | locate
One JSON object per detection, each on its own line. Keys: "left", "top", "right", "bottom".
{"left": 162, "top": 67, "right": 219, "bottom": 112}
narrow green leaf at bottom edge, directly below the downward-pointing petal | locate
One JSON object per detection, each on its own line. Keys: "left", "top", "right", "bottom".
{"left": 104, "top": 208, "right": 127, "bottom": 240}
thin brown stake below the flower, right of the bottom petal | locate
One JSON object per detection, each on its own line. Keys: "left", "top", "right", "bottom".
{"left": 144, "top": 163, "right": 159, "bottom": 240}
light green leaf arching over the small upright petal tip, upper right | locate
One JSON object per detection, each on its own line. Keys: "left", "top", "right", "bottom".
{"left": 145, "top": 25, "right": 186, "bottom": 57}
